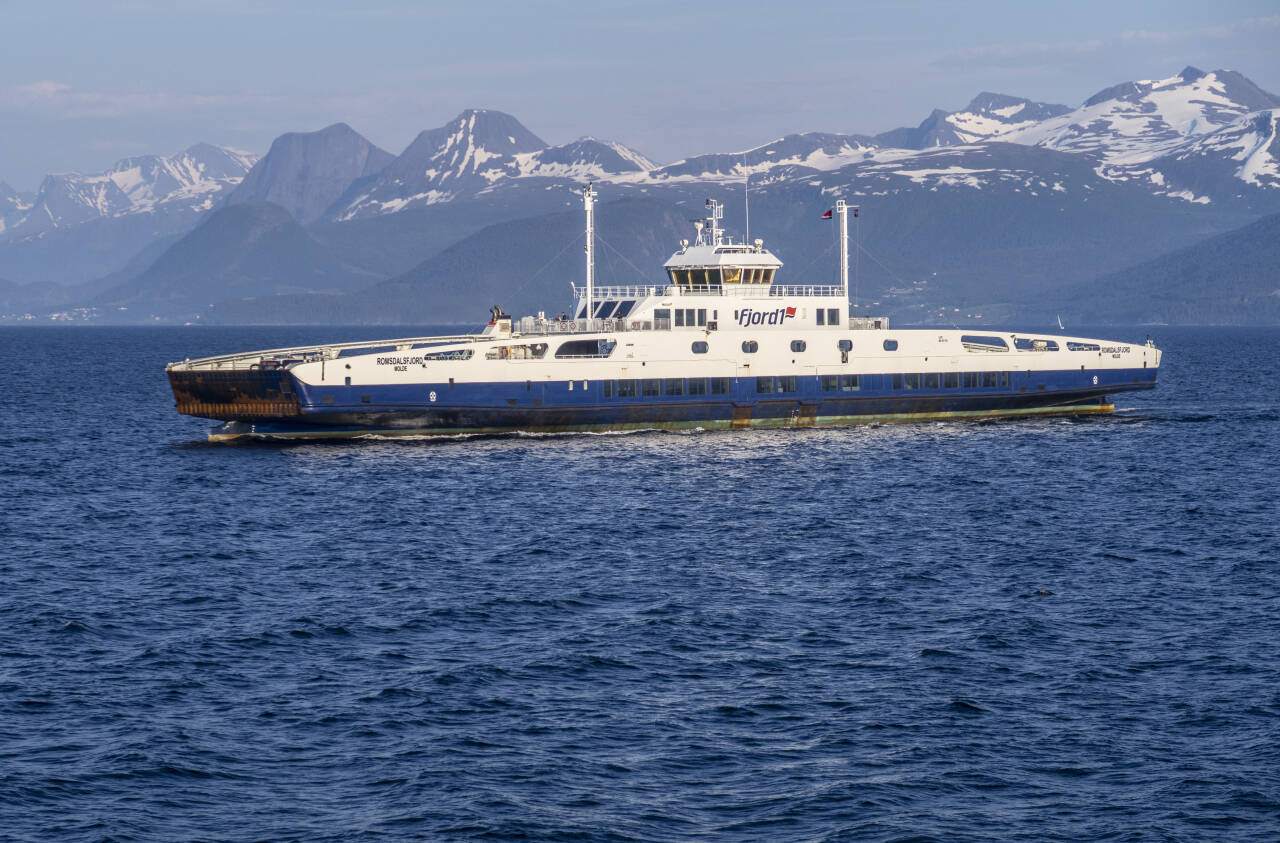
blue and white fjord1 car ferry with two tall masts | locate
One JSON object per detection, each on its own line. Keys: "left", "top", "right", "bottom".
{"left": 168, "top": 185, "right": 1161, "bottom": 441}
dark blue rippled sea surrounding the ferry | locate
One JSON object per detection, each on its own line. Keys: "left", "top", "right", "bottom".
{"left": 0, "top": 327, "right": 1280, "bottom": 842}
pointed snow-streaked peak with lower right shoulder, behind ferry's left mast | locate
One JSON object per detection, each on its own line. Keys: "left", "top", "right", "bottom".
{"left": 330, "top": 109, "right": 653, "bottom": 220}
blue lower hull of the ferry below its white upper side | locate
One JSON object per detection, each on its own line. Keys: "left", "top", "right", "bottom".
{"left": 202, "top": 368, "right": 1157, "bottom": 439}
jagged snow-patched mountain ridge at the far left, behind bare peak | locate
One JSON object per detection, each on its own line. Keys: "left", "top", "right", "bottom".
{"left": 4, "top": 143, "right": 257, "bottom": 239}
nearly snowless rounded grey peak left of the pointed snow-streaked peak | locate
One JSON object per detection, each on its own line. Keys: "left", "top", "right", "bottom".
{"left": 227, "top": 123, "right": 396, "bottom": 225}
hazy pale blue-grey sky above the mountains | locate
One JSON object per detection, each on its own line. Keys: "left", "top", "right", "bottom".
{"left": 0, "top": 0, "right": 1280, "bottom": 189}
